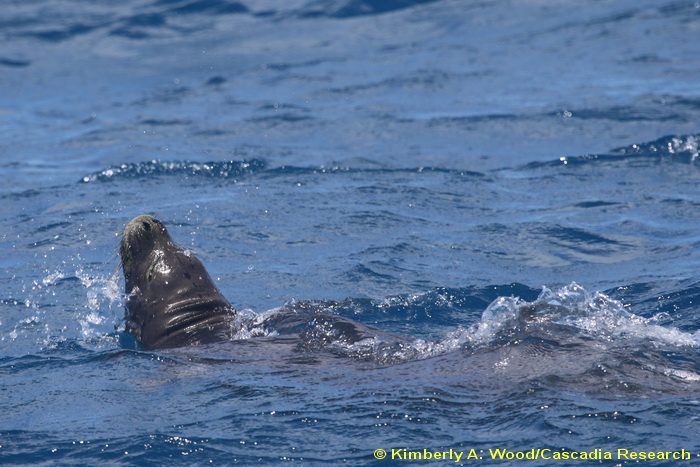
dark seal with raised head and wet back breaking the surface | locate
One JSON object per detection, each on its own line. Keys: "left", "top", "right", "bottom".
{"left": 119, "top": 215, "right": 405, "bottom": 351}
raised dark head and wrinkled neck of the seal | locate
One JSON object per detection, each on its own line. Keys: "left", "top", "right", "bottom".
{"left": 119, "top": 215, "right": 236, "bottom": 350}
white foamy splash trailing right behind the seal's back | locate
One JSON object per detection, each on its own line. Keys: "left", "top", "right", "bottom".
{"left": 322, "top": 282, "right": 700, "bottom": 364}
